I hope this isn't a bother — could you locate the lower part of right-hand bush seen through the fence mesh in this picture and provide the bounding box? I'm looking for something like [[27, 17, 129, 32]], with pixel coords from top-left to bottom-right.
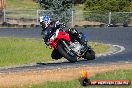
[[83, 12, 132, 24]]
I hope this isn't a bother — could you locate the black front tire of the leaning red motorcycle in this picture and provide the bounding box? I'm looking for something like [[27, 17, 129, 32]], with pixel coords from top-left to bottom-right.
[[57, 44, 77, 63]]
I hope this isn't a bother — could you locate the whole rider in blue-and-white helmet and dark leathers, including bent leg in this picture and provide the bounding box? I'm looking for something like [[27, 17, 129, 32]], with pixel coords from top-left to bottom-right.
[[40, 15, 84, 45]]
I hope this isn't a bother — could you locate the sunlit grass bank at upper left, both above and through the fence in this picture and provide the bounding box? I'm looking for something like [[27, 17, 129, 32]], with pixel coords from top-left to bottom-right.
[[6, 0, 39, 19]]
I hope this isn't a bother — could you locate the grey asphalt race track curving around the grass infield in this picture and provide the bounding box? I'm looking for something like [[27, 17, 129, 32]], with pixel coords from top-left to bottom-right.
[[0, 27, 132, 72]]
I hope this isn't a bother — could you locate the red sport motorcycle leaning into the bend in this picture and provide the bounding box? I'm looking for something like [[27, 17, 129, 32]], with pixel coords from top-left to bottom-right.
[[44, 25, 95, 63]]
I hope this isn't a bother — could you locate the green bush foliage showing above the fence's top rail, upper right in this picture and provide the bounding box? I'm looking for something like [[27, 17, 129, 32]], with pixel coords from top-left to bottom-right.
[[85, 0, 132, 12]]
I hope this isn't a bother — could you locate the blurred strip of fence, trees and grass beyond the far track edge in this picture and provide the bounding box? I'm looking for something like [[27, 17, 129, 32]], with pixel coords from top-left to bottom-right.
[[0, 0, 132, 28]]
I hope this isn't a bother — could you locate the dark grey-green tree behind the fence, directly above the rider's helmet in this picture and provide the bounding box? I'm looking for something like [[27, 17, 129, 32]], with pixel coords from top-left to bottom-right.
[[39, 0, 72, 23]]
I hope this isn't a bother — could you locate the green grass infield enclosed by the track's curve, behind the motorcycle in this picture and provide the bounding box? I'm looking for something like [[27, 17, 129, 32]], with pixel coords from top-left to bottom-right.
[[0, 37, 109, 67]]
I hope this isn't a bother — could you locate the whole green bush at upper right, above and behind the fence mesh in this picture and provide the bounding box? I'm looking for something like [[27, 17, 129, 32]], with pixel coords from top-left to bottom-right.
[[84, 0, 132, 23]]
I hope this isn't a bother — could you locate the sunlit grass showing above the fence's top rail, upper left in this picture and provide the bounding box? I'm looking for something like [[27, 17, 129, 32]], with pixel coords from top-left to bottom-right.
[[6, 0, 39, 10]]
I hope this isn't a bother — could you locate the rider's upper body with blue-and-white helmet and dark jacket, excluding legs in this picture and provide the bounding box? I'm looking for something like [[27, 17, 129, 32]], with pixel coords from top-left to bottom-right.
[[40, 15, 60, 45]]
